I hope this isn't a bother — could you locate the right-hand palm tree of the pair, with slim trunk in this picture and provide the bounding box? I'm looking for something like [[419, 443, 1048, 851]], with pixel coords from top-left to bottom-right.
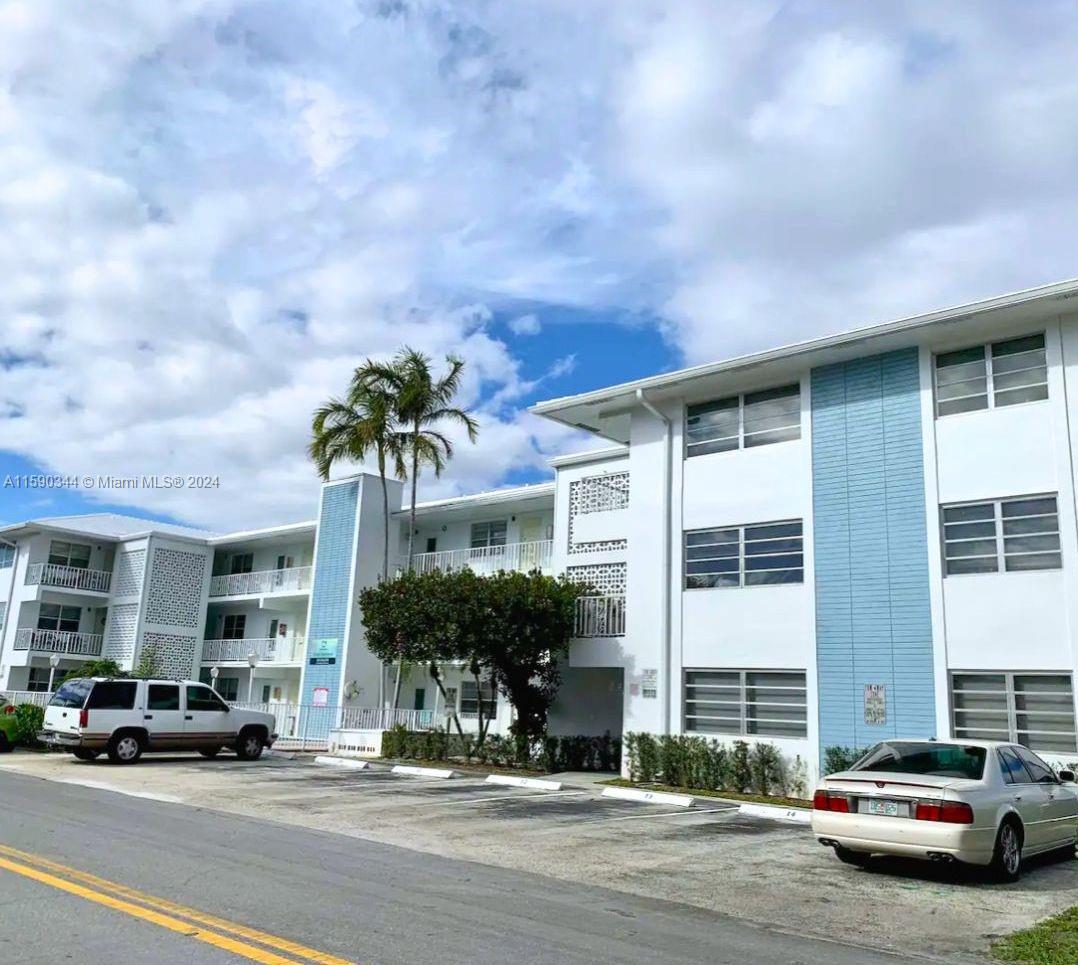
[[392, 346, 479, 573]]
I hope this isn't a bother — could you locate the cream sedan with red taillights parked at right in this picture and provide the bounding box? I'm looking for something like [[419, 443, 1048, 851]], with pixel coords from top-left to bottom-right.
[[812, 741, 1078, 881]]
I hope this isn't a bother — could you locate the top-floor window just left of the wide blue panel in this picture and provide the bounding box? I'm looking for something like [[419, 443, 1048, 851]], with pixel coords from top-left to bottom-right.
[[685, 385, 801, 457]]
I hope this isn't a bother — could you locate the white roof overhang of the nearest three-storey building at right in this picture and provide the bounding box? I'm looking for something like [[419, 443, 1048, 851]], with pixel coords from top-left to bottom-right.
[[530, 279, 1078, 444]]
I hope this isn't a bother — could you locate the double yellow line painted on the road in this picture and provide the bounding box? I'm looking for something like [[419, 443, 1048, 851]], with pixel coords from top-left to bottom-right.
[[0, 844, 353, 965]]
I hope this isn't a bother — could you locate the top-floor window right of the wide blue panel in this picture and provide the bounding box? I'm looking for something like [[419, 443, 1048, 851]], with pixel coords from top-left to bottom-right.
[[936, 333, 1048, 415]]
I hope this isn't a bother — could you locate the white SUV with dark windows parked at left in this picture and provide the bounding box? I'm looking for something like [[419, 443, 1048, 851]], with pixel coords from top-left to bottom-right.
[[38, 677, 277, 764]]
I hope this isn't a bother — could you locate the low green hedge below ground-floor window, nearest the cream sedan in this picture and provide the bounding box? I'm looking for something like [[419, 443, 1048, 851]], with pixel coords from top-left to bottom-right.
[[625, 733, 809, 797]]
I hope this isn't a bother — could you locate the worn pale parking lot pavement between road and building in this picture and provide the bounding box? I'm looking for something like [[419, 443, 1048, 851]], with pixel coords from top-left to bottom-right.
[[0, 755, 1078, 961]]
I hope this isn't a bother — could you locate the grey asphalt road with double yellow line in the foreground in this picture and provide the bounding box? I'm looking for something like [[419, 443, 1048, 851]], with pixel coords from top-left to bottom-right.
[[0, 771, 944, 965]]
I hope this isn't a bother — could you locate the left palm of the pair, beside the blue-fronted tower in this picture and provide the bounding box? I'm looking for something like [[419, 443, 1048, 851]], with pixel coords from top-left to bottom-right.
[[308, 368, 401, 580]]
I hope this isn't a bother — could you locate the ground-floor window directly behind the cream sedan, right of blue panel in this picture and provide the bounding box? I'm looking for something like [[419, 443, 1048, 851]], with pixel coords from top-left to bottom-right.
[[951, 673, 1078, 754]]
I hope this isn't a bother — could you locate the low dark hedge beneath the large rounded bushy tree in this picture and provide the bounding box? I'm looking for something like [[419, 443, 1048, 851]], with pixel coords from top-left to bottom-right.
[[382, 726, 621, 773]]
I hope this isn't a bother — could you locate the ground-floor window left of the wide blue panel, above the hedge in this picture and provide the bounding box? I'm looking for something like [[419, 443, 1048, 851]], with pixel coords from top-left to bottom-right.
[[685, 670, 809, 737]]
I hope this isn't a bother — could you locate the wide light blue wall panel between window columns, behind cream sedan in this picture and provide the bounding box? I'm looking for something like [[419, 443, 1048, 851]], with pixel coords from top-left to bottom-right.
[[812, 349, 936, 749]]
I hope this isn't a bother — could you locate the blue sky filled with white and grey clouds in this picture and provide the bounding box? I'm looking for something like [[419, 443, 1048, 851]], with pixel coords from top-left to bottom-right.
[[0, 0, 1078, 530]]
